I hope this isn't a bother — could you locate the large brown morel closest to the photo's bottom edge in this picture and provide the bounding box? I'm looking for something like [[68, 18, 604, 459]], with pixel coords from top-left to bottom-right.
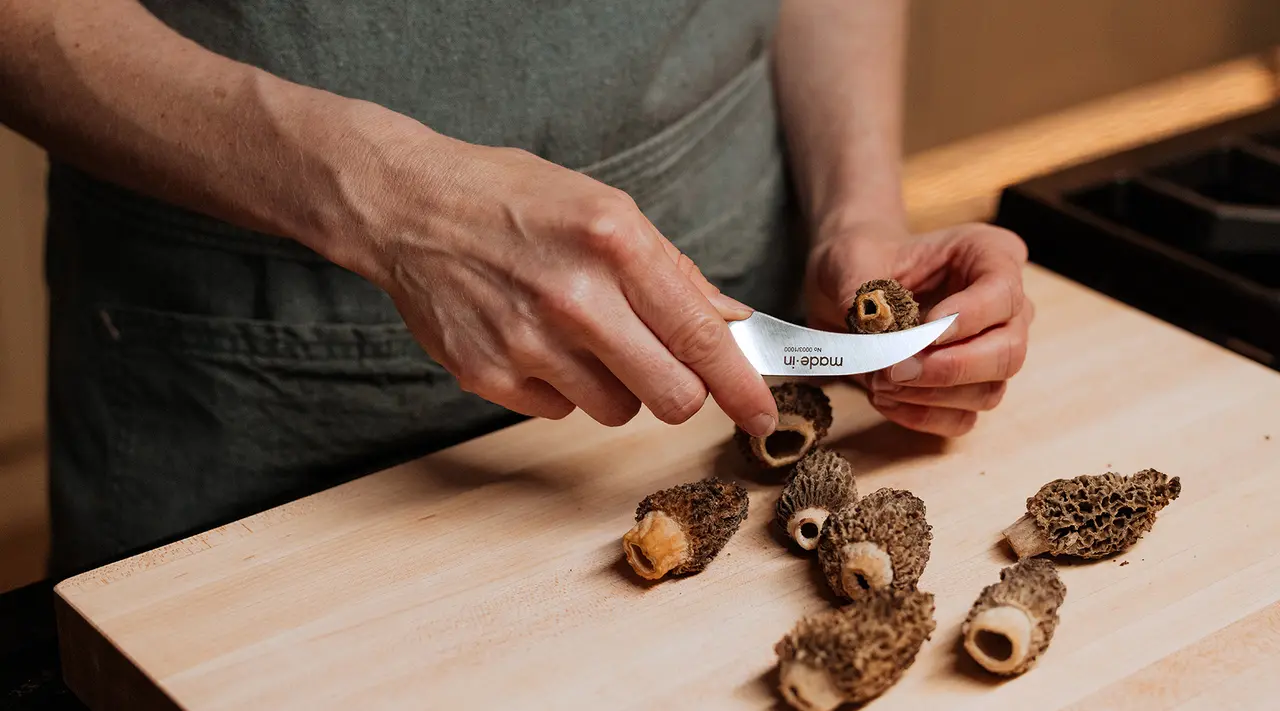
[[773, 591, 936, 711]]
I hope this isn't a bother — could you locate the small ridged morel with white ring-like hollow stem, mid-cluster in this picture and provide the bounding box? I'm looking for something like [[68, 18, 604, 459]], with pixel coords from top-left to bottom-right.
[[774, 447, 858, 551]]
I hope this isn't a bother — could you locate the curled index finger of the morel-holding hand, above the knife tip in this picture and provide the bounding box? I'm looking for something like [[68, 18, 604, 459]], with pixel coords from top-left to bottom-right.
[[925, 237, 1025, 345]]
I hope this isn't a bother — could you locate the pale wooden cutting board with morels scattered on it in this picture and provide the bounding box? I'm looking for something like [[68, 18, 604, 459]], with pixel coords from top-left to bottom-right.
[[58, 268, 1280, 711]]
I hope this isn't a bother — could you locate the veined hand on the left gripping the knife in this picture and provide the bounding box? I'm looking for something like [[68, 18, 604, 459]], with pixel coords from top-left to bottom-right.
[[337, 114, 777, 436]]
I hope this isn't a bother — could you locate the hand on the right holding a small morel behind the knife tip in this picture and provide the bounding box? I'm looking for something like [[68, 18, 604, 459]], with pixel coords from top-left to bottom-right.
[[806, 224, 1034, 437]]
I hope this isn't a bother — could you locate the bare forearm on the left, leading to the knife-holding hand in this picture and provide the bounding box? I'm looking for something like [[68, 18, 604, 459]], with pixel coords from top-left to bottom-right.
[[0, 0, 412, 275]]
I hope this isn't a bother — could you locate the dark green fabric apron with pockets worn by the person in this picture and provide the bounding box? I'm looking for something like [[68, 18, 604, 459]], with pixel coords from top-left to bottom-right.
[[47, 0, 804, 575]]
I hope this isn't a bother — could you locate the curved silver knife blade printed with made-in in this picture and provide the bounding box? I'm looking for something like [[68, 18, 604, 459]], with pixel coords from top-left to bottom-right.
[[728, 311, 959, 377]]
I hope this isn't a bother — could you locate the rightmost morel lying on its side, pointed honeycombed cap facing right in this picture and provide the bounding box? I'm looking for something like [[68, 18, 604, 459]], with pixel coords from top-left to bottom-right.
[[1005, 469, 1183, 559]]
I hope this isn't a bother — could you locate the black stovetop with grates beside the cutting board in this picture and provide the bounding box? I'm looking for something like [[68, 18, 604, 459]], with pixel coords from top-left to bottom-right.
[[995, 105, 1280, 370]]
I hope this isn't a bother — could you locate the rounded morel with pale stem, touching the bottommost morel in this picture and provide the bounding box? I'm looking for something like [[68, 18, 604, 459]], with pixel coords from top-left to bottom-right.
[[818, 488, 933, 600]]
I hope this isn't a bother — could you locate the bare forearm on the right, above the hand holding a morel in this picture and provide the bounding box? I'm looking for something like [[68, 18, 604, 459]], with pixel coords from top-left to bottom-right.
[[774, 0, 908, 240]]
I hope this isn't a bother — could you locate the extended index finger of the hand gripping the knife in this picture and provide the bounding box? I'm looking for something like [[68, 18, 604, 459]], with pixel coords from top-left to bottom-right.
[[622, 242, 778, 437]]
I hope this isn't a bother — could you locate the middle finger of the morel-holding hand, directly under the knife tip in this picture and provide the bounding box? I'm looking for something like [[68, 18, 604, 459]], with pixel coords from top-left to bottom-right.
[[887, 306, 1030, 388]]
